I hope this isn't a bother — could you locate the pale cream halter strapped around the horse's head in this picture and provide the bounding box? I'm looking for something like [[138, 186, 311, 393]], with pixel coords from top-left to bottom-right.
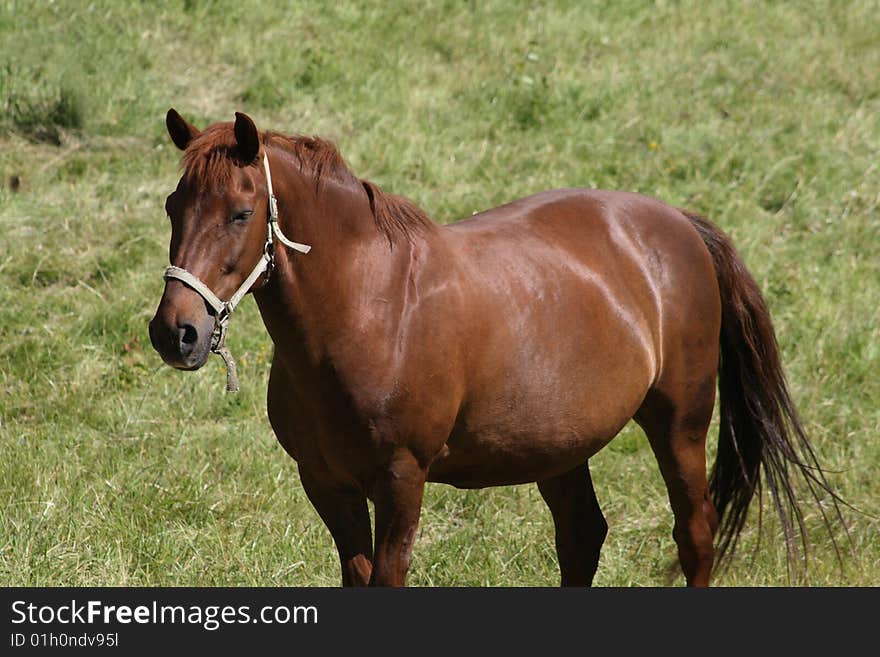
[[164, 152, 312, 392]]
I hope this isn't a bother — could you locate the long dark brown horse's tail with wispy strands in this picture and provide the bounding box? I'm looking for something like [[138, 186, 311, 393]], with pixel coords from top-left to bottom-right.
[[685, 211, 842, 561]]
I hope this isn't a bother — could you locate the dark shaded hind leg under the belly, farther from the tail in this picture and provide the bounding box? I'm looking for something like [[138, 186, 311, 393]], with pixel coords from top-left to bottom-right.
[[538, 463, 608, 586]]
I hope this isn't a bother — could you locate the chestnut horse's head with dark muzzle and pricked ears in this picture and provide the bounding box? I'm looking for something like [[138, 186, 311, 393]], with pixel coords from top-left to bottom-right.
[[150, 109, 268, 370]]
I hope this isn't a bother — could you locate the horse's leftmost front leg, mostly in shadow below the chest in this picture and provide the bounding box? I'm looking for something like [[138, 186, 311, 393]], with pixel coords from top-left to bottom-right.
[[299, 465, 373, 586]]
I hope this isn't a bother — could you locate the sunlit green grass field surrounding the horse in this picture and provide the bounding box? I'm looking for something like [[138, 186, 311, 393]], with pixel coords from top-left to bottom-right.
[[0, 0, 880, 586]]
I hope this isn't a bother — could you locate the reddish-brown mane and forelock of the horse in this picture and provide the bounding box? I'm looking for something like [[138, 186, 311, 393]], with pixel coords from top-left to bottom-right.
[[183, 123, 431, 244]]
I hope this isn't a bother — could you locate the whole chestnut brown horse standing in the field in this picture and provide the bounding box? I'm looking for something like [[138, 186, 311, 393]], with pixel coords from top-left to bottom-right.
[[150, 110, 836, 586]]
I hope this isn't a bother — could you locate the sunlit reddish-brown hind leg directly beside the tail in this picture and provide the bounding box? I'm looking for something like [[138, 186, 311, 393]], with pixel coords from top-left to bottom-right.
[[635, 372, 718, 586]]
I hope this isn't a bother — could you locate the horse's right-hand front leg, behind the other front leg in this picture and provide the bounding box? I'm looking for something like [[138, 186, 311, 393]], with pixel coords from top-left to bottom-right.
[[370, 449, 427, 586]]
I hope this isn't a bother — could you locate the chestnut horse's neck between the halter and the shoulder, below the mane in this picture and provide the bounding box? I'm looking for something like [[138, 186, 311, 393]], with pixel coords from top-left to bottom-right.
[[255, 157, 424, 364]]
